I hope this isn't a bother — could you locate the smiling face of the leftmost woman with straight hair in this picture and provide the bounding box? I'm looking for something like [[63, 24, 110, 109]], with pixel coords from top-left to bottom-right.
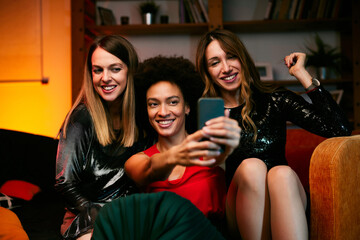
[[91, 47, 128, 103]]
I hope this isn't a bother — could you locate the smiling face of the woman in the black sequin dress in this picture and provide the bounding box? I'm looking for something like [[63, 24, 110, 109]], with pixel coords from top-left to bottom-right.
[[205, 40, 241, 92]]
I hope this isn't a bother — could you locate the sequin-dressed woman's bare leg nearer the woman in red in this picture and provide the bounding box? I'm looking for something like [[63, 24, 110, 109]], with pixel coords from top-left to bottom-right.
[[226, 158, 270, 240]]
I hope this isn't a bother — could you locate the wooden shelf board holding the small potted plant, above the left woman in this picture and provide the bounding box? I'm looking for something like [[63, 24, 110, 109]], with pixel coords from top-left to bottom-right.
[[86, 23, 208, 35]]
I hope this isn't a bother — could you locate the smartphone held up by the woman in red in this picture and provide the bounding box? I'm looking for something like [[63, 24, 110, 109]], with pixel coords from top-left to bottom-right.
[[197, 98, 224, 129]]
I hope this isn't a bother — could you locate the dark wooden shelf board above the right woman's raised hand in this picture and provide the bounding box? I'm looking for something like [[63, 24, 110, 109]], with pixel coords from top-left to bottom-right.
[[223, 19, 351, 33]]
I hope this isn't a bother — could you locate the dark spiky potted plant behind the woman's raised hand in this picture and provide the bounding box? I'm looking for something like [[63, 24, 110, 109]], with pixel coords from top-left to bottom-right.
[[305, 34, 342, 79]]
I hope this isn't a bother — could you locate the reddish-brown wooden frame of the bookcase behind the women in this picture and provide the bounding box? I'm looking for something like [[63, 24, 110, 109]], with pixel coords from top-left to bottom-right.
[[71, 0, 360, 129]]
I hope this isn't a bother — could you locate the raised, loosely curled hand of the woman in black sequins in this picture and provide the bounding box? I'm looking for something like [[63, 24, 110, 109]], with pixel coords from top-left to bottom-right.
[[284, 52, 312, 89]]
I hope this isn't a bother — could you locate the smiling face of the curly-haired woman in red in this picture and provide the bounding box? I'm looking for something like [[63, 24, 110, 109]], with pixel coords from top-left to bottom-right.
[[146, 81, 190, 140]]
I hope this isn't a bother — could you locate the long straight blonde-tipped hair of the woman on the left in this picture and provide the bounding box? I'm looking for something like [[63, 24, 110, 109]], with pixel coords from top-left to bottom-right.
[[63, 35, 138, 147]]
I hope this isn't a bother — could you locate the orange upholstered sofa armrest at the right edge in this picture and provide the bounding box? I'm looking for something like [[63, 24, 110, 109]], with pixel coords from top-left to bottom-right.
[[309, 135, 360, 240]]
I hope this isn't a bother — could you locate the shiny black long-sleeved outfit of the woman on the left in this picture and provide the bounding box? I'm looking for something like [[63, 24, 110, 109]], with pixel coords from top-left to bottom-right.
[[55, 105, 146, 238]]
